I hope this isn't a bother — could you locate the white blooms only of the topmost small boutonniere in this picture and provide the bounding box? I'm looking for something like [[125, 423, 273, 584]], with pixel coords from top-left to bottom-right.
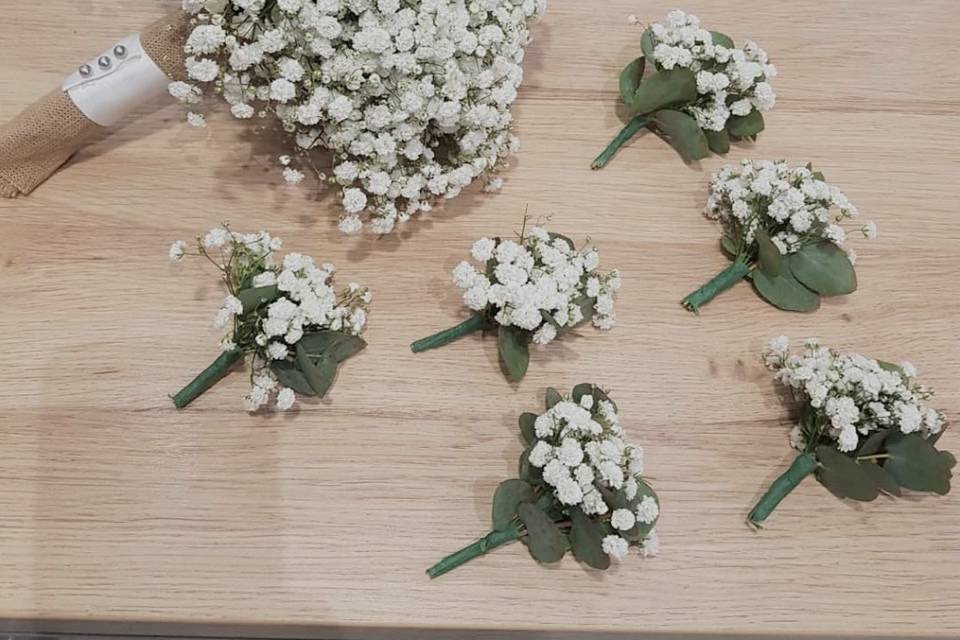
[[650, 10, 777, 131]]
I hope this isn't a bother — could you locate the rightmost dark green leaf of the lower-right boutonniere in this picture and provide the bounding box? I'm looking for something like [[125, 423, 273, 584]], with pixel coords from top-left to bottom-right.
[[883, 431, 953, 495]]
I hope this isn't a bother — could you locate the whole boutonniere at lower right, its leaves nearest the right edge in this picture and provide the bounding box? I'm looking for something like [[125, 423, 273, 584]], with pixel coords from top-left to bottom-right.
[[749, 336, 957, 526]]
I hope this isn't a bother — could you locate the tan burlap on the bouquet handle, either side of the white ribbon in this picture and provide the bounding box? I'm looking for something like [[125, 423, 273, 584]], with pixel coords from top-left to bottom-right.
[[0, 12, 190, 198]]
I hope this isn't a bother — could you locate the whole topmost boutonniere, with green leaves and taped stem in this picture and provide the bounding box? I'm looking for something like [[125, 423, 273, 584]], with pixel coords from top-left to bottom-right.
[[593, 11, 777, 169]]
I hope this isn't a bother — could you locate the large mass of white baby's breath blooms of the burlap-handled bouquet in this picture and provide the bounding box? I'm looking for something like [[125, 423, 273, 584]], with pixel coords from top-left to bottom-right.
[[170, 0, 546, 234]]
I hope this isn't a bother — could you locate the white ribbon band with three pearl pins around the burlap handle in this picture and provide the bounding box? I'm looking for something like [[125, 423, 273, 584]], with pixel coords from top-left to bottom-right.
[[62, 33, 170, 127]]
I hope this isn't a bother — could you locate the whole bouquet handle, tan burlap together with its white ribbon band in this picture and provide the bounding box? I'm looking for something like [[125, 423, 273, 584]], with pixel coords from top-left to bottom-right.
[[0, 12, 190, 198]]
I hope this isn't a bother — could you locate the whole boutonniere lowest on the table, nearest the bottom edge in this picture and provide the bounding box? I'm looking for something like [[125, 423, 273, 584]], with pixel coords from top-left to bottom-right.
[[427, 384, 660, 578]]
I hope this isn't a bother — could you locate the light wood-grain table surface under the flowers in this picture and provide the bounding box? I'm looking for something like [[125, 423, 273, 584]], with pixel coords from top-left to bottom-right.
[[0, 0, 960, 638]]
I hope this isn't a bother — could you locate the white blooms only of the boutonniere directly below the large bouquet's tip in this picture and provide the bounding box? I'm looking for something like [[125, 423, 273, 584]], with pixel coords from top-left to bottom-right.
[[453, 227, 620, 344]]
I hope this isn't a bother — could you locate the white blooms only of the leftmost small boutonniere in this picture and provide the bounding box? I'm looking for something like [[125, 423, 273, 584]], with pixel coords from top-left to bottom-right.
[[169, 227, 371, 412]]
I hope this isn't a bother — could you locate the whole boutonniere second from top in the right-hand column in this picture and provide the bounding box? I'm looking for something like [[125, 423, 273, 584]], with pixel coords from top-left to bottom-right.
[[683, 160, 877, 313]]
